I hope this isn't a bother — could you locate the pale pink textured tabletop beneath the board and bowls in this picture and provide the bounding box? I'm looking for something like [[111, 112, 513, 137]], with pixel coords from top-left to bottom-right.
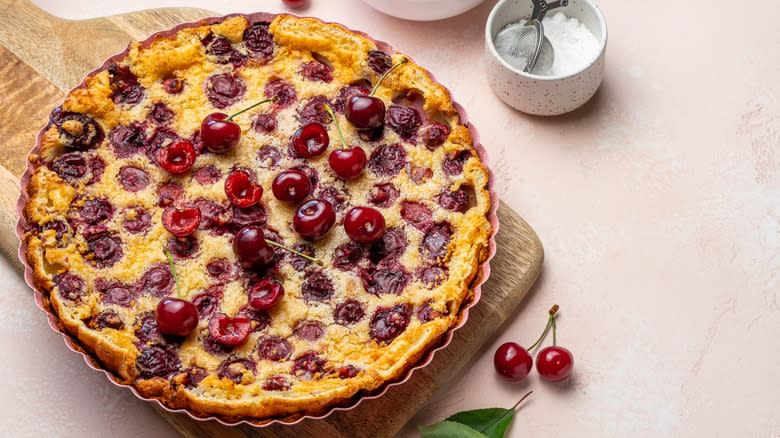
[[0, 0, 780, 438]]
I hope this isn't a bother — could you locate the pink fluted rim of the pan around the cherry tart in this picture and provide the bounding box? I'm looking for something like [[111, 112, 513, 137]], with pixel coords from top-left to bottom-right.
[[16, 13, 498, 427]]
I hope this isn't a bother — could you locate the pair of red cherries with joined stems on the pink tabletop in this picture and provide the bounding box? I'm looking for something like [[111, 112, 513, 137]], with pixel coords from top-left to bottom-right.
[[493, 304, 574, 382]]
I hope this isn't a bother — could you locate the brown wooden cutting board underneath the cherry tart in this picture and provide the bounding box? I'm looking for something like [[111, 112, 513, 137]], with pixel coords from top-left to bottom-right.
[[0, 0, 543, 438]]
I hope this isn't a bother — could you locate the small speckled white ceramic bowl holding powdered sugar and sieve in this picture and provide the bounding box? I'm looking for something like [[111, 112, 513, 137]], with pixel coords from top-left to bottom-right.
[[485, 0, 607, 116]]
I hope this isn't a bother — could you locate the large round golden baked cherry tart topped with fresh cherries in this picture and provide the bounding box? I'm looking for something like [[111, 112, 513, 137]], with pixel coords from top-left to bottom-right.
[[21, 14, 493, 424]]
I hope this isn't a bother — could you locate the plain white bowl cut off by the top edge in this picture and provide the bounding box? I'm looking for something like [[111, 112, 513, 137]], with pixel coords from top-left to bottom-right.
[[363, 0, 485, 21]]
